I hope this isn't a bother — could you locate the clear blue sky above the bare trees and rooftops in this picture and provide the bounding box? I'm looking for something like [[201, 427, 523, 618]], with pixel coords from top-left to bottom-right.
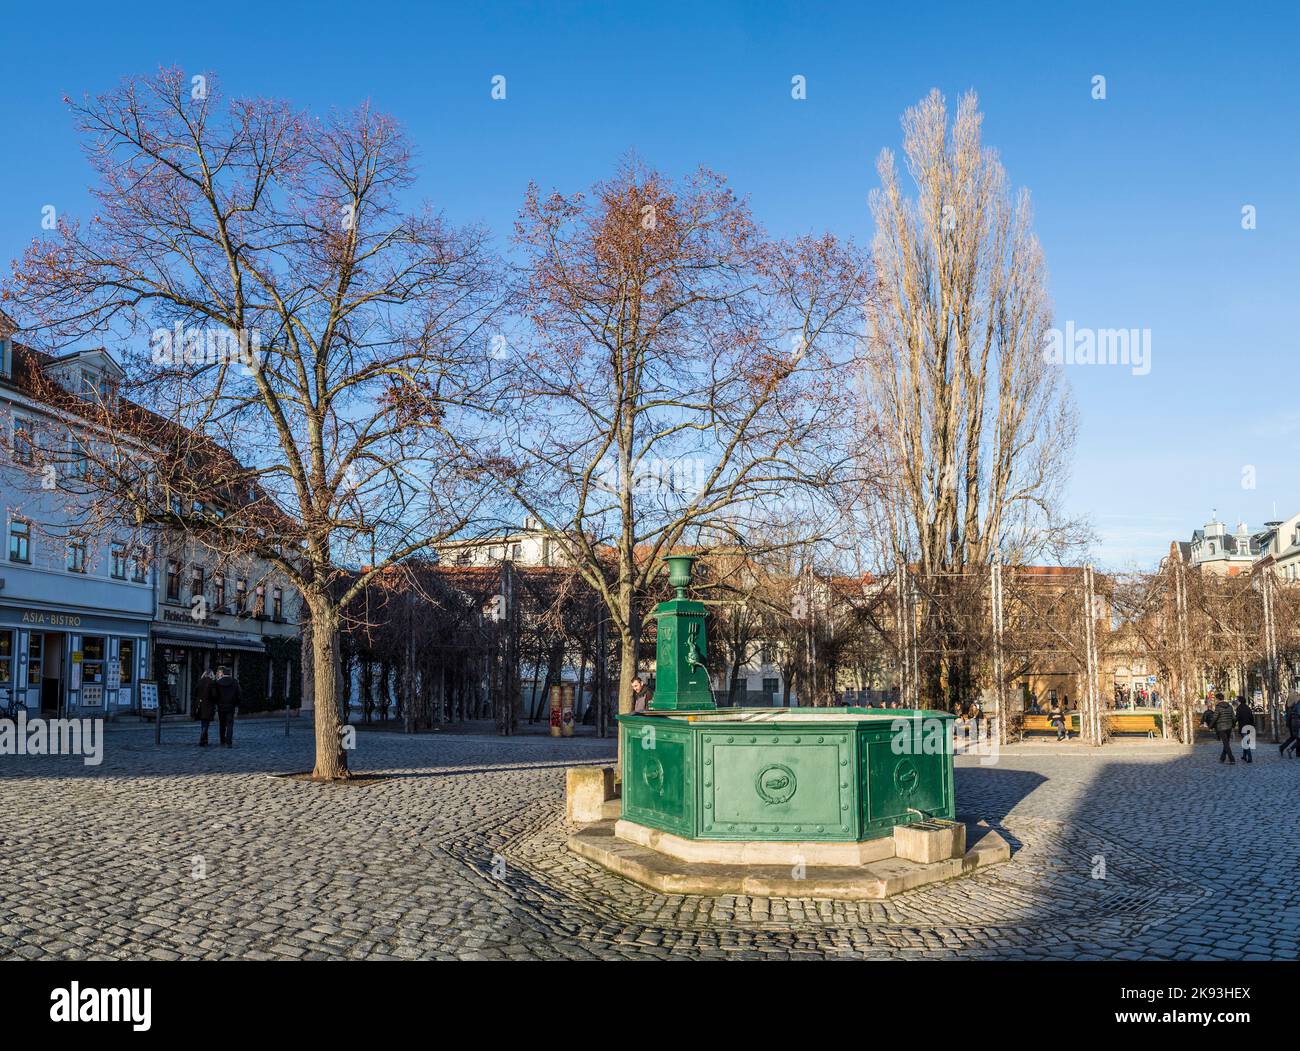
[[0, 0, 1300, 566]]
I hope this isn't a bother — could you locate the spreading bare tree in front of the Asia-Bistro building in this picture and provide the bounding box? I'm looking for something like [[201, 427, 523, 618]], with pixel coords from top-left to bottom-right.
[[3, 70, 494, 779]]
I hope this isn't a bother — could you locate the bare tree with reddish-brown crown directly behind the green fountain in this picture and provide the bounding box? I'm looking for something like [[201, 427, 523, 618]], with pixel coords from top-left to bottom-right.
[[491, 161, 868, 738]]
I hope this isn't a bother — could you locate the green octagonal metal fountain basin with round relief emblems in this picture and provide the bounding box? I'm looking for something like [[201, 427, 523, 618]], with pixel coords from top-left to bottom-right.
[[619, 708, 954, 842]]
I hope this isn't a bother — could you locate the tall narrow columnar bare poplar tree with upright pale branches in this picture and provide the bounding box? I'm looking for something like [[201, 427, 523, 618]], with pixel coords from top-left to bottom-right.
[[863, 90, 1087, 712]]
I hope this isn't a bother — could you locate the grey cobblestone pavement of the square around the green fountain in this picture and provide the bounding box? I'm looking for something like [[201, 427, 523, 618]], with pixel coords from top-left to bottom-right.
[[0, 721, 1300, 960]]
